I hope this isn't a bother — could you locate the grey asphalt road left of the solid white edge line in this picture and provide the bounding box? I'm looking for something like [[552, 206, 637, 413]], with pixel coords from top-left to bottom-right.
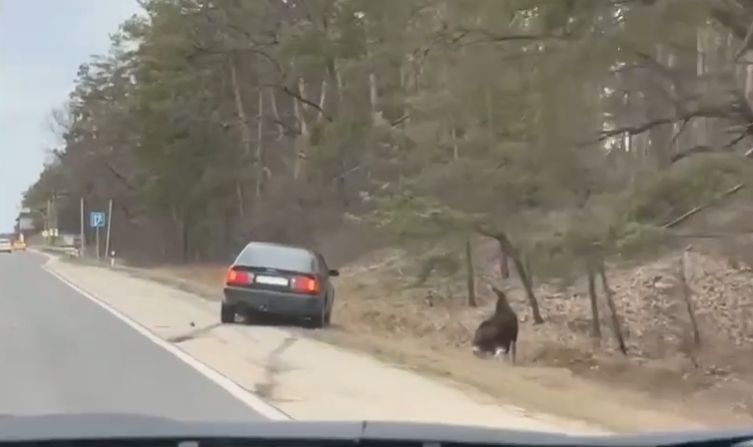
[[0, 253, 263, 421]]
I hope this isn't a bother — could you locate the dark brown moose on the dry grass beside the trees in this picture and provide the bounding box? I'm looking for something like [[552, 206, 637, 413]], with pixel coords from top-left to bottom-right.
[[473, 285, 518, 363]]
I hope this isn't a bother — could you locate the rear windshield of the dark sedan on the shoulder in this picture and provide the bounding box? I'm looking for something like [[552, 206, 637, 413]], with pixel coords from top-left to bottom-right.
[[235, 244, 316, 273]]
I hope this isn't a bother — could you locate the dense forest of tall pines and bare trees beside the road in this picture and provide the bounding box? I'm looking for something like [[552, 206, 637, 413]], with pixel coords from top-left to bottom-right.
[[23, 0, 753, 292]]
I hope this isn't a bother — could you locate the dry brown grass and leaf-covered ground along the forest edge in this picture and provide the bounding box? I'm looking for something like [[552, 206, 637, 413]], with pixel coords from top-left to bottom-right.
[[137, 246, 753, 431]]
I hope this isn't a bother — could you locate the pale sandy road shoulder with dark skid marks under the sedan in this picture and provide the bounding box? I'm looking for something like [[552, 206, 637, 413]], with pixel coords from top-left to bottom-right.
[[39, 257, 605, 433]]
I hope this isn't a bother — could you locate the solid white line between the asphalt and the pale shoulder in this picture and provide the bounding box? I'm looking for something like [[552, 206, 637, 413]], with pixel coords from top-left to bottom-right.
[[43, 258, 292, 420]]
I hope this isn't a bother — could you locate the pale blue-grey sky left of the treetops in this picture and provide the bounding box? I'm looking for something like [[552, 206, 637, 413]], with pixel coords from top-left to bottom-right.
[[0, 0, 139, 233]]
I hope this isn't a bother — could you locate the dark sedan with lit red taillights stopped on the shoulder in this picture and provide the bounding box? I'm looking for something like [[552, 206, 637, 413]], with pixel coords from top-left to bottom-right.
[[220, 242, 339, 327]]
